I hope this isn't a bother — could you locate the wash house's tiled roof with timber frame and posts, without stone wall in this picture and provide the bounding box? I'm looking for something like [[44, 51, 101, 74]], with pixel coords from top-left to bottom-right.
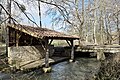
[[8, 24, 79, 68]]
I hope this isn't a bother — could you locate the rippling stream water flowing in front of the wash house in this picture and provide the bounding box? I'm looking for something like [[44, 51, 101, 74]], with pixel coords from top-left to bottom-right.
[[0, 58, 100, 80]]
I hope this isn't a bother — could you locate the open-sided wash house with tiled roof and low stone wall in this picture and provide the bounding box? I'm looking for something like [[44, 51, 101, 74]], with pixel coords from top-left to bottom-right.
[[7, 24, 79, 71]]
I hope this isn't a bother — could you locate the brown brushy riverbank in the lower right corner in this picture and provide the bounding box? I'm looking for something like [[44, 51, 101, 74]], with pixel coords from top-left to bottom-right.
[[96, 53, 120, 80]]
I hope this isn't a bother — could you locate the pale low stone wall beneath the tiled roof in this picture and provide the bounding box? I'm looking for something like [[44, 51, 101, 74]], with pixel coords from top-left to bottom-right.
[[8, 46, 54, 68]]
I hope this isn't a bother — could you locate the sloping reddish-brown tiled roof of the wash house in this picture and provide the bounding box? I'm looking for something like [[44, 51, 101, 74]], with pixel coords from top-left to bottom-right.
[[9, 25, 79, 39]]
